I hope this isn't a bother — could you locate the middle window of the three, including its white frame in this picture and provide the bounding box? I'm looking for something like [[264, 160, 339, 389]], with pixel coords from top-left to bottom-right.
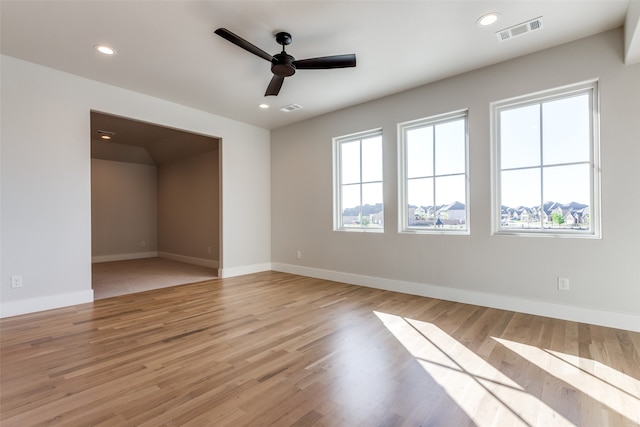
[[398, 110, 469, 234]]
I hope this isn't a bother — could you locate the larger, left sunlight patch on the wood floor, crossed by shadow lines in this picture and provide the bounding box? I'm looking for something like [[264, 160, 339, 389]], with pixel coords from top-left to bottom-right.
[[374, 311, 574, 426]]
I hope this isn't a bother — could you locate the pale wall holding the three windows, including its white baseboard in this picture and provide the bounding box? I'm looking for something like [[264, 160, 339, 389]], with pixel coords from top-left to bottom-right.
[[271, 30, 640, 330]]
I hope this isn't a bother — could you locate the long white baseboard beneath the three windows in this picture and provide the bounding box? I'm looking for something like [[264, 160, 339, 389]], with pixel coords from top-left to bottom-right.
[[271, 263, 640, 332]]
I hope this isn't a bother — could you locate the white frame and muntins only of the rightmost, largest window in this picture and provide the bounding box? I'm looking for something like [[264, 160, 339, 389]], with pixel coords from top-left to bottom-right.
[[490, 79, 602, 239]]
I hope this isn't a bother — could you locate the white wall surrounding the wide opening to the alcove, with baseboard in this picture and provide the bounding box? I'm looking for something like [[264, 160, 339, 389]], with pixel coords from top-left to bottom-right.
[[0, 55, 271, 316]]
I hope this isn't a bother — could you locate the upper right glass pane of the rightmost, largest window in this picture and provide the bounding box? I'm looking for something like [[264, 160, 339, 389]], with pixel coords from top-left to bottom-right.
[[542, 94, 590, 165]]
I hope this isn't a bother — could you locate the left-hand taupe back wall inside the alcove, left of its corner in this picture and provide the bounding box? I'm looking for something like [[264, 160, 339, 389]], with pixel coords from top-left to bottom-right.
[[91, 159, 158, 259]]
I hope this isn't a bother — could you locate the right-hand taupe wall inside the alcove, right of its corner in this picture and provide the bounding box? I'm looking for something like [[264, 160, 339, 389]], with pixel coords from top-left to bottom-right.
[[158, 151, 220, 261]]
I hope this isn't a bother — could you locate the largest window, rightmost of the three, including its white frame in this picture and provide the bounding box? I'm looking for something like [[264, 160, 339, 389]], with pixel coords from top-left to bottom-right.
[[492, 82, 599, 237]]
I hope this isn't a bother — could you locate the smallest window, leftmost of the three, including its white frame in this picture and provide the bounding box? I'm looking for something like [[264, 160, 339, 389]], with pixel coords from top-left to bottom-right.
[[333, 130, 384, 232]]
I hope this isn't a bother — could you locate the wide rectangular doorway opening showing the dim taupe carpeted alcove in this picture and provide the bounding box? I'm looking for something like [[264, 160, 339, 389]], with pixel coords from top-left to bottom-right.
[[91, 111, 221, 299]]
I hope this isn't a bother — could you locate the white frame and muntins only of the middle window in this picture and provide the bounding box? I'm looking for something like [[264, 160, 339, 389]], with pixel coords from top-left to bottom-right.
[[397, 108, 471, 235]]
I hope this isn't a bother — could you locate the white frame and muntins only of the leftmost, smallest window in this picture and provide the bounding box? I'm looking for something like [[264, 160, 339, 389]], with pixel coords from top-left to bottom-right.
[[332, 128, 386, 233]]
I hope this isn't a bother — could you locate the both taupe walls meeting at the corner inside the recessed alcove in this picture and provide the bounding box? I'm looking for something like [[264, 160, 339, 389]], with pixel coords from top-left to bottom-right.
[[91, 149, 220, 268]]
